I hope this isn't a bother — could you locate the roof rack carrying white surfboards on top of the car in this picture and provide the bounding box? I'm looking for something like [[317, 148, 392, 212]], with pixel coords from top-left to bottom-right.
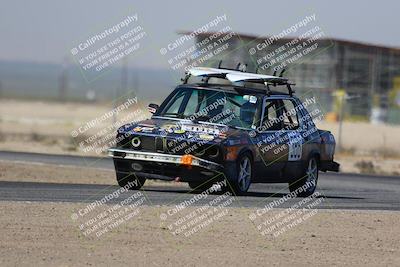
[[182, 60, 295, 96]]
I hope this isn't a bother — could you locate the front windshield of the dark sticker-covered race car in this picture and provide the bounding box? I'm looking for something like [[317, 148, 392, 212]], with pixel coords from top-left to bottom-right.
[[155, 88, 261, 129]]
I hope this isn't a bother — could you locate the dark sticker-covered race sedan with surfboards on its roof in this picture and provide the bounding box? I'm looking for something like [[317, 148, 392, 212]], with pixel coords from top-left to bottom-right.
[[108, 68, 339, 196]]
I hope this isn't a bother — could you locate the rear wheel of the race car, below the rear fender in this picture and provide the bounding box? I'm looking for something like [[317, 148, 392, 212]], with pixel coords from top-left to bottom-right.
[[289, 156, 319, 197]]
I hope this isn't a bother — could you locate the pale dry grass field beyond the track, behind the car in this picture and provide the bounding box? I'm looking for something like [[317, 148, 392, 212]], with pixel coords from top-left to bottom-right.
[[0, 99, 400, 175]]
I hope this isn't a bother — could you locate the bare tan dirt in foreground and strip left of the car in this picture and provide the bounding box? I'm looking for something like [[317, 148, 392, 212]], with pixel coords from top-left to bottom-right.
[[0, 161, 400, 266]]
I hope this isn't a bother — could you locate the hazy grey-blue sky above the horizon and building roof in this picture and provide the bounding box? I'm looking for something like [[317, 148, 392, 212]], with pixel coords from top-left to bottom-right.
[[0, 0, 400, 68]]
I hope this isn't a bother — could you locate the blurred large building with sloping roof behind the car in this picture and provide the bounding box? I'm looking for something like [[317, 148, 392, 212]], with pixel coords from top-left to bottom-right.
[[183, 32, 400, 122]]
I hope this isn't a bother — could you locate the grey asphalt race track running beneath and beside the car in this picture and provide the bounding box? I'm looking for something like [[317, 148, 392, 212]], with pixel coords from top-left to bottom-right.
[[0, 151, 400, 210]]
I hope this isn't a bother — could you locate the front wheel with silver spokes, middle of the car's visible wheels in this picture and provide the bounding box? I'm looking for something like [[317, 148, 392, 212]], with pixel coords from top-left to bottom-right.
[[226, 153, 253, 195]]
